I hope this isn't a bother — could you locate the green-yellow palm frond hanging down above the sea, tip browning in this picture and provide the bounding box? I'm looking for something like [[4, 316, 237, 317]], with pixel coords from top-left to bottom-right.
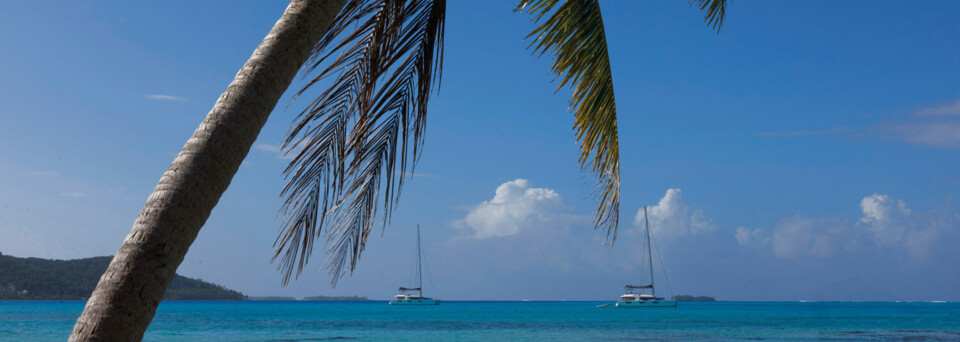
[[516, 0, 620, 242]]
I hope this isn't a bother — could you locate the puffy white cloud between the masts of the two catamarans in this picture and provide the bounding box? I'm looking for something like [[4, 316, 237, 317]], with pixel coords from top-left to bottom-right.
[[454, 179, 562, 239]]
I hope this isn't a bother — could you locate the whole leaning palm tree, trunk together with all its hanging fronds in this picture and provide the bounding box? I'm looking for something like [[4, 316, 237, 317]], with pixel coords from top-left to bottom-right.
[[70, 0, 725, 341]]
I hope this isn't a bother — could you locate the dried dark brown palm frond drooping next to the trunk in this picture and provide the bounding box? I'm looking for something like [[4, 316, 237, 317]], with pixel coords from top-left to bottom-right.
[[273, 0, 446, 286]]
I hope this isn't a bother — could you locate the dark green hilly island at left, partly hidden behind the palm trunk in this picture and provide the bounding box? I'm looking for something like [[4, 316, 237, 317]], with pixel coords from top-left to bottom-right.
[[0, 254, 246, 300]]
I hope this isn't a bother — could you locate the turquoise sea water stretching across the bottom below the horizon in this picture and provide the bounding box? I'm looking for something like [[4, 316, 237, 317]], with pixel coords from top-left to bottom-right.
[[0, 301, 960, 341]]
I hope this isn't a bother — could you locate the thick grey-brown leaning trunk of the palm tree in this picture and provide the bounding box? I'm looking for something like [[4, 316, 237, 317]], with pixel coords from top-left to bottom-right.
[[70, 0, 344, 341]]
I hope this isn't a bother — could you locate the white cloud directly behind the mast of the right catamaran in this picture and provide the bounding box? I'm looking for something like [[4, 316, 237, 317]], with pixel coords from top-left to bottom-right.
[[633, 188, 716, 241]]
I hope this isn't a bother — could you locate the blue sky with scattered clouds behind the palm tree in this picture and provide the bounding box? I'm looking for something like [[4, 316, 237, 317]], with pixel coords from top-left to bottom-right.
[[0, 1, 960, 300]]
